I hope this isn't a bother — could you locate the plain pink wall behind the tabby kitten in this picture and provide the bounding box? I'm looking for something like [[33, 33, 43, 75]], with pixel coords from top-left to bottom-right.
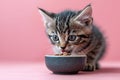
[[0, 0, 120, 62]]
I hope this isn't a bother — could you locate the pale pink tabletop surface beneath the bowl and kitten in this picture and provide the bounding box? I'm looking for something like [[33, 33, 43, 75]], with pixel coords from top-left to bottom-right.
[[0, 63, 120, 80]]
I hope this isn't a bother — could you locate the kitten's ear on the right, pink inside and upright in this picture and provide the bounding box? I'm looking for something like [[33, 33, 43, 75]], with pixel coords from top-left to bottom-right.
[[73, 5, 93, 26]]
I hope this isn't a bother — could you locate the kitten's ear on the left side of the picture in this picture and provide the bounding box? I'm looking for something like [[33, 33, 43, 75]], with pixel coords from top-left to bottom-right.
[[39, 8, 54, 24]]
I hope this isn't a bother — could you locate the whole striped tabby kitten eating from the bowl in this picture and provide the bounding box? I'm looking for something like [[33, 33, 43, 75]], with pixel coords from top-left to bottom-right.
[[39, 5, 105, 71]]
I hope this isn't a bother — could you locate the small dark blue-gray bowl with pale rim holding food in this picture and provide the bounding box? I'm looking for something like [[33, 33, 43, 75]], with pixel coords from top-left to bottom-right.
[[45, 55, 86, 74]]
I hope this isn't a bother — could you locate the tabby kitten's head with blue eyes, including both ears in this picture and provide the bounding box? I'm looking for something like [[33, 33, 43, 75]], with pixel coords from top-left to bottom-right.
[[39, 5, 93, 53]]
